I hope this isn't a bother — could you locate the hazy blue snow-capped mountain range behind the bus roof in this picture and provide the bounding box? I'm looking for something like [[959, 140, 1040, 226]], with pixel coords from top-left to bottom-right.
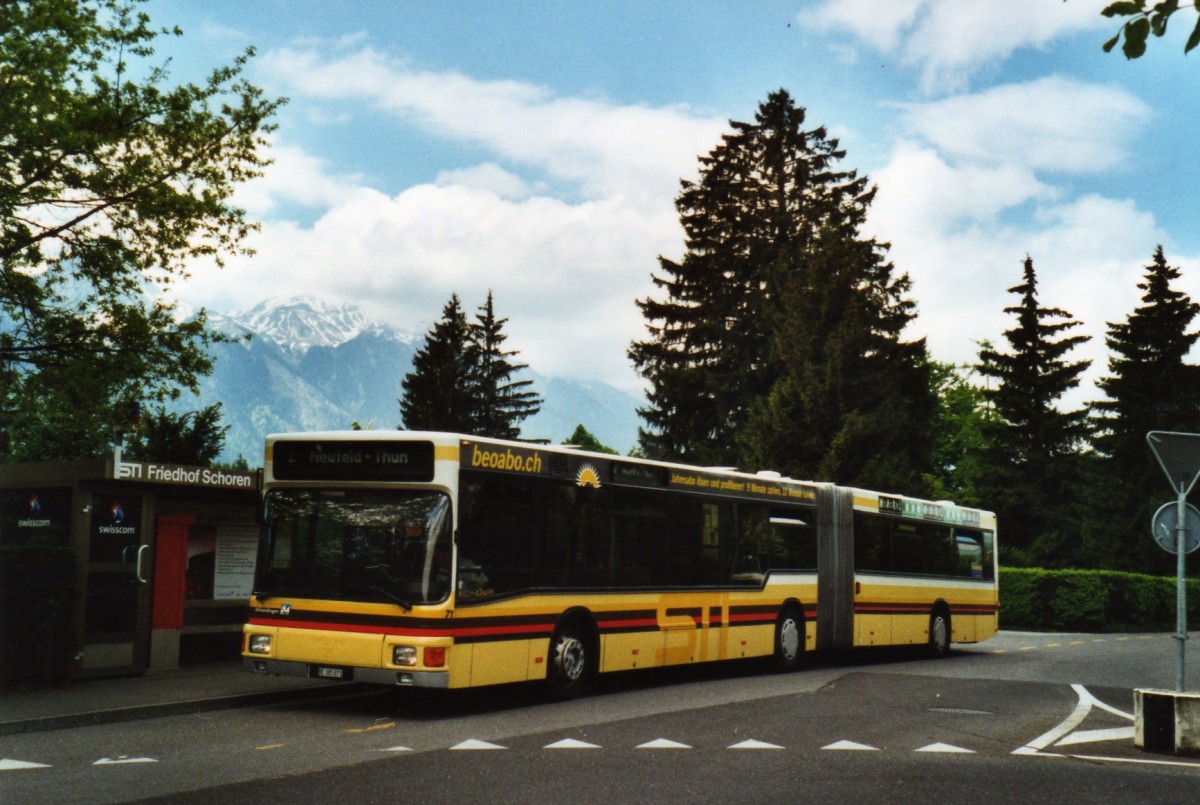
[[175, 298, 642, 465]]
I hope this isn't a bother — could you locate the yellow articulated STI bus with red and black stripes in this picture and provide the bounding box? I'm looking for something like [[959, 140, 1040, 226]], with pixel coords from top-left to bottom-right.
[[242, 431, 998, 696]]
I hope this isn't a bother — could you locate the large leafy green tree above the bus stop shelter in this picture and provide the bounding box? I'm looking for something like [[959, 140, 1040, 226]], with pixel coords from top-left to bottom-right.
[[0, 0, 281, 458]]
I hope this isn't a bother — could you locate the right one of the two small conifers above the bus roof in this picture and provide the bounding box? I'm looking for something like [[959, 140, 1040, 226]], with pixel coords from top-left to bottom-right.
[[470, 290, 541, 439]]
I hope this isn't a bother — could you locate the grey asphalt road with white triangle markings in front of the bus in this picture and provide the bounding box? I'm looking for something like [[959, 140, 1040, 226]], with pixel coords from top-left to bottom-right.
[[7, 633, 1200, 804]]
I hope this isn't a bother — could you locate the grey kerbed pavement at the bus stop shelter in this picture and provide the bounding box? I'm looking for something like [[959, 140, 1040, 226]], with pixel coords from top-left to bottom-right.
[[0, 657, 349, 735]]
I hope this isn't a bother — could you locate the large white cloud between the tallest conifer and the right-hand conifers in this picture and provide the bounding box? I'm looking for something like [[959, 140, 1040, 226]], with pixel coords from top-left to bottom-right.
[[870, 77, 1165, 407]]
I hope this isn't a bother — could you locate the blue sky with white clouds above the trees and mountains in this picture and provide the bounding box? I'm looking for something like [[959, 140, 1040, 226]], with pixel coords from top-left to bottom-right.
[[146, 0, 1200, 401]]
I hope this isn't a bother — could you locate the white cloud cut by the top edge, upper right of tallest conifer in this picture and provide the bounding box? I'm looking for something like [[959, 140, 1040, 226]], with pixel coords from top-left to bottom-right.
[[798, 0, 1111, 92]]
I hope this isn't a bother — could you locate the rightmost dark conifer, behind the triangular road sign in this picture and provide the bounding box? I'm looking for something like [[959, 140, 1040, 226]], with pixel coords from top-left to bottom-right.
[[1084, 246, 1200, 572]]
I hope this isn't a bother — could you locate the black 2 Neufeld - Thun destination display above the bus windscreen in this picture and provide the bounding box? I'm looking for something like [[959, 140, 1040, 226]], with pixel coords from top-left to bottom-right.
[[271, 440, 433, 482]]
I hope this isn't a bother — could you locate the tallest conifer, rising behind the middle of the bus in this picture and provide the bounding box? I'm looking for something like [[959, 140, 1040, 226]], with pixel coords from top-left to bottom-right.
[[629, 90, 874, 464]]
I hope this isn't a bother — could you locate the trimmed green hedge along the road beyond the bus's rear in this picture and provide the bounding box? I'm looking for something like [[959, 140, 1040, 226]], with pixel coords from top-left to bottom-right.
[[1000, 567, 1200, 632]]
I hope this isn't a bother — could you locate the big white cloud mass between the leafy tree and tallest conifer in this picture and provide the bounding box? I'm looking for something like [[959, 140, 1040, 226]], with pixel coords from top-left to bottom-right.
[[180, 44, 725, 388]]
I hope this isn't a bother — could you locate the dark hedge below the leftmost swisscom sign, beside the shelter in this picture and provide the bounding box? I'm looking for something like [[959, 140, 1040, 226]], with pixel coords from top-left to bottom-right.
[[0, 546, 78, 690]]
